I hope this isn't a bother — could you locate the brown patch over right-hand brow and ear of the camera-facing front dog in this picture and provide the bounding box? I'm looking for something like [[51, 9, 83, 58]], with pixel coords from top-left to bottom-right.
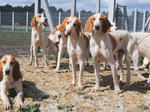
[[100, 14, 111, 33]]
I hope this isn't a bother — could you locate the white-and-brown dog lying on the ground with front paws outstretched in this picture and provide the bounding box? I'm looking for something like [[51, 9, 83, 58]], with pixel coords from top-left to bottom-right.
[[0, 54, 23, 110]]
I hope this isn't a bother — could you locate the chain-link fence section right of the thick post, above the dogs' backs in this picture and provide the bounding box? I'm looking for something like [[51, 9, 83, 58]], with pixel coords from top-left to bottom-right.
[[116, 5, 150, 32]]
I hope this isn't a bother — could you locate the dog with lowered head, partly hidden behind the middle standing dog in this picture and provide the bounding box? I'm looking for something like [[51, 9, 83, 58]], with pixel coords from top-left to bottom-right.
[[47, 25, 70, 71]]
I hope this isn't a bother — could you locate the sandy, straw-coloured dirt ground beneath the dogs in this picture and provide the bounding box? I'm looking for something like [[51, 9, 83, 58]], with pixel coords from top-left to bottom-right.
[[0, 55, 150, 112]]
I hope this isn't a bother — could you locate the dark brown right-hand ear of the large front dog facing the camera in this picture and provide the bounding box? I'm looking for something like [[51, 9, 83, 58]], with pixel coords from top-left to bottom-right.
[[102, 16, 111, 33]]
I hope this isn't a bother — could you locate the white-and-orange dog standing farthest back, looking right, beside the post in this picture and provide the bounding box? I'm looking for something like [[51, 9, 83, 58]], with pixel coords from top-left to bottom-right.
[[29, 14, 48, 68]]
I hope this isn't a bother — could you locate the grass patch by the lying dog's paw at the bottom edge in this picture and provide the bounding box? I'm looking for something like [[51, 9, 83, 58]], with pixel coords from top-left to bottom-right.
[[17, 103, 40, 112]]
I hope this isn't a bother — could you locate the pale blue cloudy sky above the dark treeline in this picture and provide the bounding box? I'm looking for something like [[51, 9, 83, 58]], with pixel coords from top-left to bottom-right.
[[0, 0, 150, 12]]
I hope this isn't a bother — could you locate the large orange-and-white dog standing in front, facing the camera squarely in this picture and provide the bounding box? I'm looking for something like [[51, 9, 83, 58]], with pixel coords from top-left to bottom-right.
[[85, 13, 130, 93]]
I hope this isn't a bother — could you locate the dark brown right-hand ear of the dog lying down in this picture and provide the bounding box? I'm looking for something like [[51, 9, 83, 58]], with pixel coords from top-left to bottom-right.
[[13, 60, 21, 81]]
